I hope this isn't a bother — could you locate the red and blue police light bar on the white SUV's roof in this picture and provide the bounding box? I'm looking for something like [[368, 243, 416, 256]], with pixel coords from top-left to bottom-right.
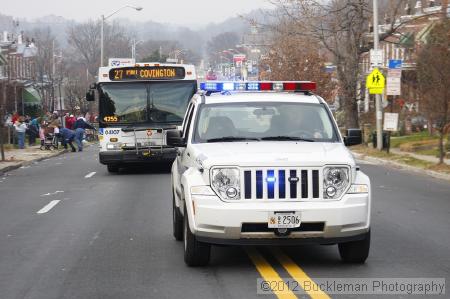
[[200, 81, 316, 92]]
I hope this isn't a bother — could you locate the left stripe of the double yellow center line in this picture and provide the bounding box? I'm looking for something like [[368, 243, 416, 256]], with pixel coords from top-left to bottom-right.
[[245, 247, 298, 299]]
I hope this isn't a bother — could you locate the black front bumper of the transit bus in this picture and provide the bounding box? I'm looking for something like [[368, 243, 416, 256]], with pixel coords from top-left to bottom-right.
[[99, 148, 177, 165]]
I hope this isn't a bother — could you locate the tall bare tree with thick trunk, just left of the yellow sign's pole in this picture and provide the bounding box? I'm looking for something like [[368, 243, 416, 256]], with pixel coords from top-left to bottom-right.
[[273, 0, 410, 128]]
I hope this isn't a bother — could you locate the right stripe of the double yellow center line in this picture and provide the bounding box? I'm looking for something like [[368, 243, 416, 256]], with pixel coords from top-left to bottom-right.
[[271, 247, 330, 299]]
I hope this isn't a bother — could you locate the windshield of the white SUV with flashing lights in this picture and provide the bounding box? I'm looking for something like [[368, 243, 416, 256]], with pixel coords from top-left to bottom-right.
[[194, 102, 338, 143]]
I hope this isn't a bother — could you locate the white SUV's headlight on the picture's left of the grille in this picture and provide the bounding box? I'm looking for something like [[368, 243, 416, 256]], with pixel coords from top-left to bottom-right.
[[211, 168, 241, 200]]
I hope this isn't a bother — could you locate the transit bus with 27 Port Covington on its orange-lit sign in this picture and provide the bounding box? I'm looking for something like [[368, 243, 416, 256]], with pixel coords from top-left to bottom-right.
[[86, 63, 197, 172]]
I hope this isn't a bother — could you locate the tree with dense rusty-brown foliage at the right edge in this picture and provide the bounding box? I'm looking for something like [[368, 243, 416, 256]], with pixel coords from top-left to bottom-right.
[[417, 19, 450, 163]]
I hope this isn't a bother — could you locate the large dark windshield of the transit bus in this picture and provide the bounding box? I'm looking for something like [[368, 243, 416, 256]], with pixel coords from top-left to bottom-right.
[[99, 81, 197, 124]]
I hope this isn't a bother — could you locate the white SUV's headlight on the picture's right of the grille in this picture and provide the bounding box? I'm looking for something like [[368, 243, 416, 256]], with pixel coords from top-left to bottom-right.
[[323, 167, 350, 199]]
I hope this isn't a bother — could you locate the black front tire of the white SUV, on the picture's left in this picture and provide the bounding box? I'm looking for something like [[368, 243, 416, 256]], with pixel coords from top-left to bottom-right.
[[183, 207, 211, 267]]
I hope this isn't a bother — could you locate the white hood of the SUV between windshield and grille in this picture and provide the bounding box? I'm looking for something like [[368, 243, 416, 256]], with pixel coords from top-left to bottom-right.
[[191, 141, 355, 168]]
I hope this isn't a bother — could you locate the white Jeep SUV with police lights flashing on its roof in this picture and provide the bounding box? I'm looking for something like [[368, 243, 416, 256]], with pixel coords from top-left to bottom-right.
[[167, 82, 371, 266]]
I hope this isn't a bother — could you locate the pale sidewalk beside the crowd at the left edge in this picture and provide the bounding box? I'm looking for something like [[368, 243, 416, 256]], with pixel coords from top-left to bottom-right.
[[0, 145, 66, 174]]
